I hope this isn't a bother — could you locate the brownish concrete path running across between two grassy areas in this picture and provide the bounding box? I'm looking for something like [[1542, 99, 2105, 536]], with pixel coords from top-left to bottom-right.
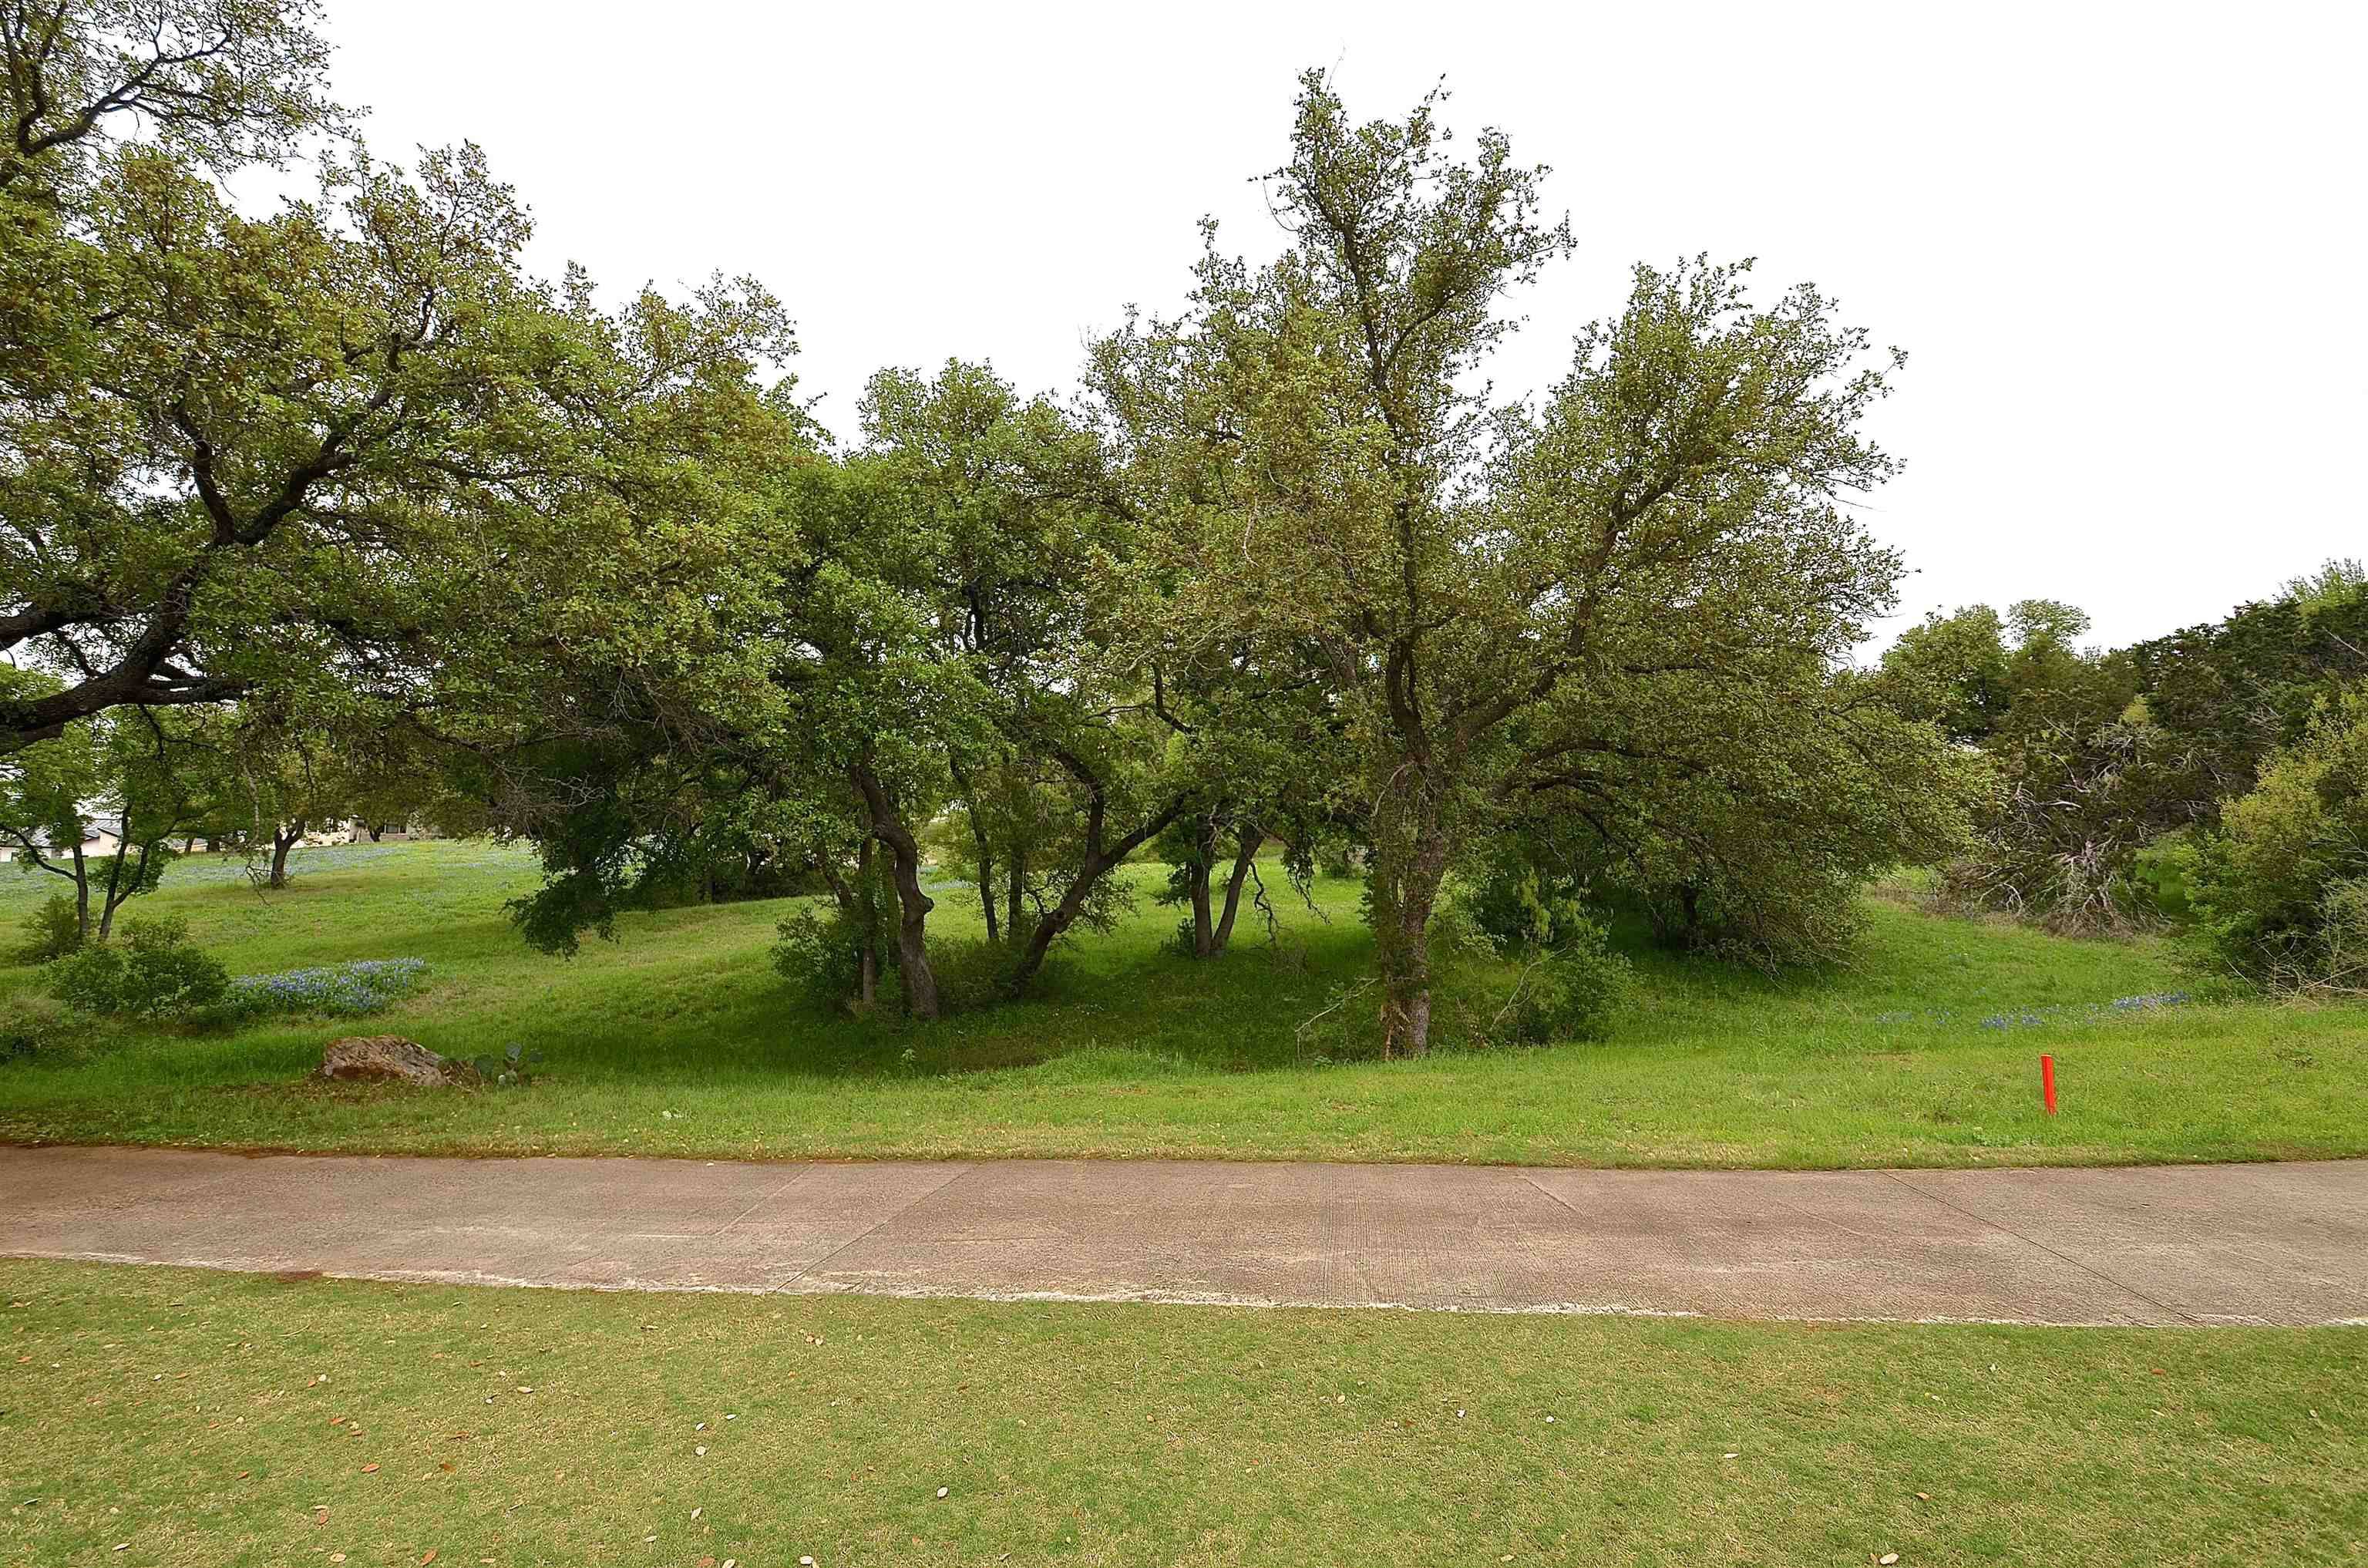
[[0, 1149, 2368, 1324]]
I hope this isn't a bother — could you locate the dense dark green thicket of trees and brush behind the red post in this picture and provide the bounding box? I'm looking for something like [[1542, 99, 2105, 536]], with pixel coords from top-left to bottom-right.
[[1878, 561, 2368, 990]]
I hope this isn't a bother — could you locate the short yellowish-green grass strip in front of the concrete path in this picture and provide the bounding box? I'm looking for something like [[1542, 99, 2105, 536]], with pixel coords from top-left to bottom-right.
[[0, 1263, 2368, 1568]]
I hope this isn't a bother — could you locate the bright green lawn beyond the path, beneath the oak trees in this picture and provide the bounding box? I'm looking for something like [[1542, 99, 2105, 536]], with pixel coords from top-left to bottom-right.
[[0, 843, 2368, 1168]]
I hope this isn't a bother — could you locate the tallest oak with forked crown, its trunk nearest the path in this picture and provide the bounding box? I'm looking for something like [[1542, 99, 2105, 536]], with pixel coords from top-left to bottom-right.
[[1094, 73, 1970, 1054]]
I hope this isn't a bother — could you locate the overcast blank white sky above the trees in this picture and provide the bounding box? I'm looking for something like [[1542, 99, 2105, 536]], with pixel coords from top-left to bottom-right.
[[305, 0, 2368, 644]]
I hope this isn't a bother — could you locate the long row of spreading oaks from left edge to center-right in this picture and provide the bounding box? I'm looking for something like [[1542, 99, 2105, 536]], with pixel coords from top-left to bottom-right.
[[0, 0, 1986, 1054]]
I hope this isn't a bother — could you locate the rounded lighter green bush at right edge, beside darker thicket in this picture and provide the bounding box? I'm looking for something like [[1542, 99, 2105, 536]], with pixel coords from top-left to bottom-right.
[[2178, 685, 2368, 994]]
